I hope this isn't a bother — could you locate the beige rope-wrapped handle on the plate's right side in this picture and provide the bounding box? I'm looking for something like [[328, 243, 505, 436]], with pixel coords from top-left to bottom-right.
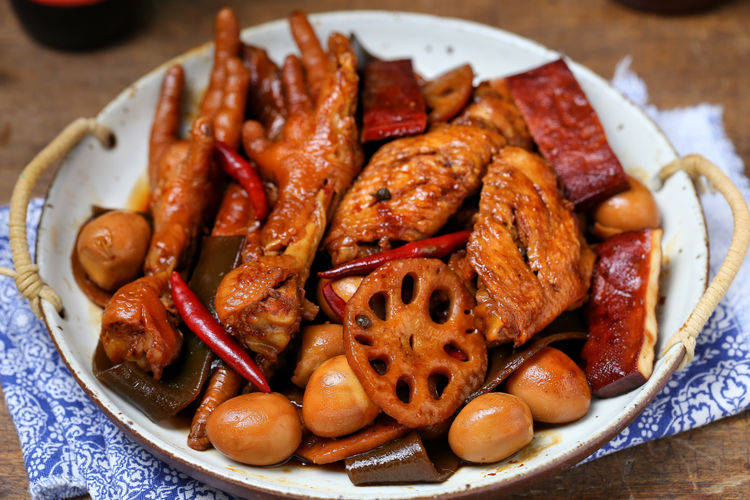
[[659, 155, 750, 370]]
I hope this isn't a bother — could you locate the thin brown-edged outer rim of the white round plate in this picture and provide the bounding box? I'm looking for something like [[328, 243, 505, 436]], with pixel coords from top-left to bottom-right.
[[34, 9, 710, 500]]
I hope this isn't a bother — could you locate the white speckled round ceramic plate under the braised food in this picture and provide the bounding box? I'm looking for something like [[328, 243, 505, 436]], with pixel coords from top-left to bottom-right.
[[37, 11, 708, 498]]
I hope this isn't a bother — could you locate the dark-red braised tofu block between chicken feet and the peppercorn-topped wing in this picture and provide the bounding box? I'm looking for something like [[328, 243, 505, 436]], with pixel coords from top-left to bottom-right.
[[362, 59, 427, 142]]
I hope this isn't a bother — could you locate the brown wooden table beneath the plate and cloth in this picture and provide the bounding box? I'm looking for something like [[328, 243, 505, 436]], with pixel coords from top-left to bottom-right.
[[0, 0, 750, 498]]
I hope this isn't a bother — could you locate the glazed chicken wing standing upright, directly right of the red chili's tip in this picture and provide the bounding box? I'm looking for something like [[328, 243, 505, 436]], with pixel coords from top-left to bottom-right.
[[467, 147, 594, 345]]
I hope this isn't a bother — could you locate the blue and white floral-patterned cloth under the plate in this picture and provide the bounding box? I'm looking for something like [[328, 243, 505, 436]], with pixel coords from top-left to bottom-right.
[[0, 60, 750, 499]]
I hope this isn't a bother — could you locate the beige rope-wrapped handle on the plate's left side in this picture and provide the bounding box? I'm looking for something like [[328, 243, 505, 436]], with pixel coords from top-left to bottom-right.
[[0, 118, 114, 319]]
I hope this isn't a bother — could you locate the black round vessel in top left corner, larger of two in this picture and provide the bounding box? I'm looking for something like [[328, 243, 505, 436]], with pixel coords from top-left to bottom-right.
[[11, 0, 142, 50]]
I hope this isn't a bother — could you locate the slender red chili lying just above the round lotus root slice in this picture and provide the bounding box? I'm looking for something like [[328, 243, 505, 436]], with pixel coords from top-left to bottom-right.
[[318, 231, 471, 282]]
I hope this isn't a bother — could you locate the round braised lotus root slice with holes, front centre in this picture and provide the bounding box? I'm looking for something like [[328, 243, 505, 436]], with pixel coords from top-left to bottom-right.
[[344, 259, 487, 427]]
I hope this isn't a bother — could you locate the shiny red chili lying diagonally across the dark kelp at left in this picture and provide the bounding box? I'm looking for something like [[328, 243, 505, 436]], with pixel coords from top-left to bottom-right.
[[169, 272, 271, 392]]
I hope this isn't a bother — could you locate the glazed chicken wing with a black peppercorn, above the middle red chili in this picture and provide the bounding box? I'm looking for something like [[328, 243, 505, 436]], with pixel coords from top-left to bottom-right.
[[324, 125, 504, 265]]
